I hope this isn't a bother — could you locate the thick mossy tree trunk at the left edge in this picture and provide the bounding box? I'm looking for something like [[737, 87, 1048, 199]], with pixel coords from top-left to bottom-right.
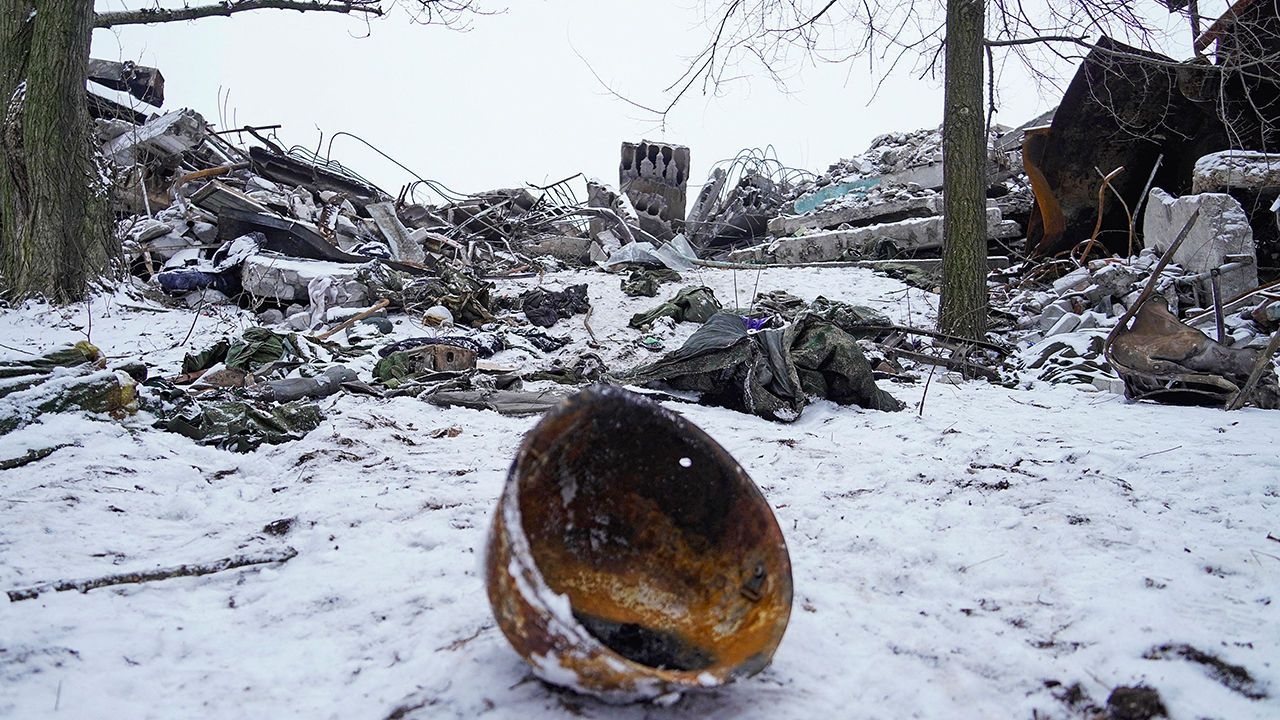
[[0, 0, 119, 302]]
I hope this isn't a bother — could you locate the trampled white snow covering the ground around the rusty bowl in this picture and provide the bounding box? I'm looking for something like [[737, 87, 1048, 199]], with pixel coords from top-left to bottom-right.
[[0, 269, 1280, 720]]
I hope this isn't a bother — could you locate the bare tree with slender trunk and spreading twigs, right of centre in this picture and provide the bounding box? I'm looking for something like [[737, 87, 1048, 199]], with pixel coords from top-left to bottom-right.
[[680, 0, 1198, 338]]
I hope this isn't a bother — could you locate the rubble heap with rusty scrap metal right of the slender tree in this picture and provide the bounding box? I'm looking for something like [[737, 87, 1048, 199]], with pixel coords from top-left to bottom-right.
[[993, 170, 1280, 407]]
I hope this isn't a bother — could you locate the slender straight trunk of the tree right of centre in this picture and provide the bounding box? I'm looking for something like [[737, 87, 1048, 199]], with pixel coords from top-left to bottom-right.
[[938, 0, 987, 340]]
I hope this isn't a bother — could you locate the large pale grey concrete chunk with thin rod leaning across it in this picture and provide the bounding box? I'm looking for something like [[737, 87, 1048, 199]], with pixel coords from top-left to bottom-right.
[[1143, 187, 1258, 297]]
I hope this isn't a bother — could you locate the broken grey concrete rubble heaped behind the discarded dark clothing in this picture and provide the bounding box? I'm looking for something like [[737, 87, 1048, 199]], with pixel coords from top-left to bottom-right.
[[70, 37, 1280, 421]]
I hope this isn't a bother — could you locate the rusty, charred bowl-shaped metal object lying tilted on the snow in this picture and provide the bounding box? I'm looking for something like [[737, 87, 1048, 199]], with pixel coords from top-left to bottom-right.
[[485, 386, 791, 702]]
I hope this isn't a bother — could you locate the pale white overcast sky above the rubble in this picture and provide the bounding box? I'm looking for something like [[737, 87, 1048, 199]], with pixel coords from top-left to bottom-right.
[[93, 0, 1187, 202]]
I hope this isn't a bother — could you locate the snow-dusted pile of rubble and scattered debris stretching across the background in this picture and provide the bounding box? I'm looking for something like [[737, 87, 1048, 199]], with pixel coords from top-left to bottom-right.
[[32, 16, 1280, 448]]
